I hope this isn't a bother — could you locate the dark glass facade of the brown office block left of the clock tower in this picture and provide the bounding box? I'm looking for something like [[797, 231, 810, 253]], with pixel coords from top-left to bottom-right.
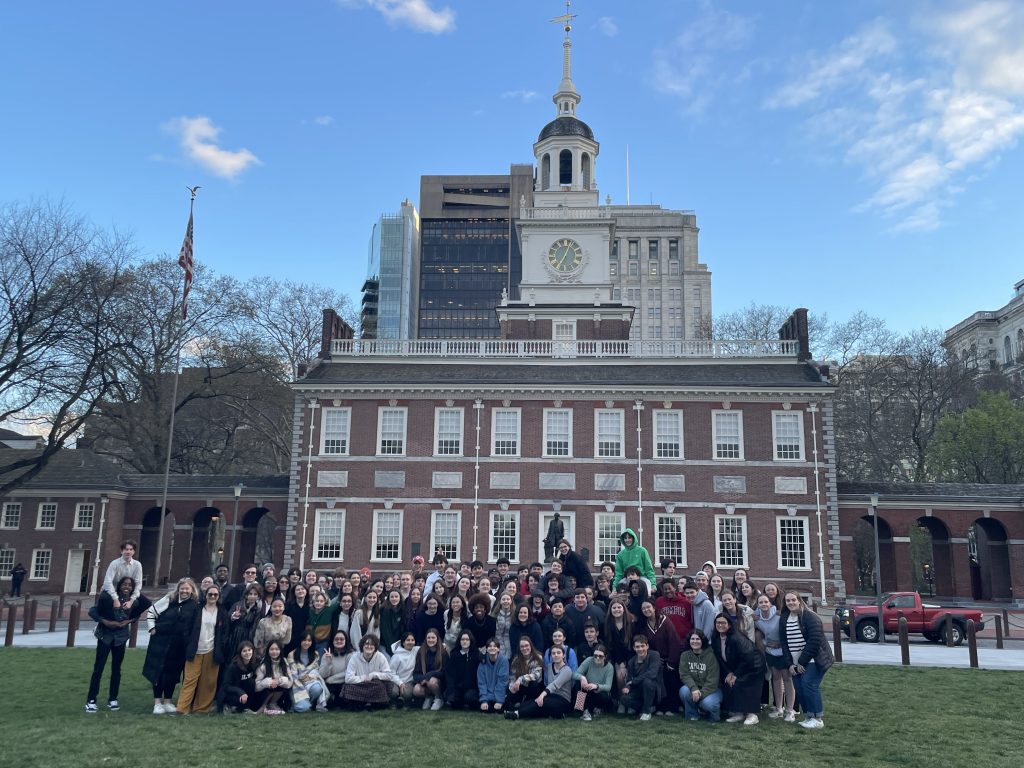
[[418, 217, 521, 339]]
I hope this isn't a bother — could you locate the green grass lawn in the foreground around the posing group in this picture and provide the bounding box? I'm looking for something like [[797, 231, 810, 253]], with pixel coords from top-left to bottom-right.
[[6, 648, 1024, 768]]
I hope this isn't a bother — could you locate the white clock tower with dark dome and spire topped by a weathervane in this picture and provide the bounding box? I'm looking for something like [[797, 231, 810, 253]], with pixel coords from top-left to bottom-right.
[[498, 2, 633, 339]]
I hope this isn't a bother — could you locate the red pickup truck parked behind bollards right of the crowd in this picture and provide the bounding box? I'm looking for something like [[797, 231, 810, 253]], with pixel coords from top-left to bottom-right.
[[836, 592, 985, 645]]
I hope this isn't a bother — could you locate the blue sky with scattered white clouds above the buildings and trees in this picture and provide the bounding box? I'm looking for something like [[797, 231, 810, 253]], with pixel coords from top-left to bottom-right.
[[0, 0, 1024, 330]]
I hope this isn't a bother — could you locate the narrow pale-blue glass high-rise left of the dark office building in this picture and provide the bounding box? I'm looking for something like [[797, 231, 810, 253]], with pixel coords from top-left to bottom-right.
[[360, 200, 420, 339]]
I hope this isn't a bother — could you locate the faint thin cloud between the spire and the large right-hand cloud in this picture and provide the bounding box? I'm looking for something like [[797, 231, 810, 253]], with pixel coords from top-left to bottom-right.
[[651, 5, 754, 114]]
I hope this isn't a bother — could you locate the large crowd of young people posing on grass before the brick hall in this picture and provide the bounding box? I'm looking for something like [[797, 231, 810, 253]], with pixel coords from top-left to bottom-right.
[[86, 529, 833, 729]]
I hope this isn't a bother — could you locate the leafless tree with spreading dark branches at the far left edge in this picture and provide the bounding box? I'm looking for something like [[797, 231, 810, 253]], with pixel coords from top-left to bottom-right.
[[0, 202, 133, 494]]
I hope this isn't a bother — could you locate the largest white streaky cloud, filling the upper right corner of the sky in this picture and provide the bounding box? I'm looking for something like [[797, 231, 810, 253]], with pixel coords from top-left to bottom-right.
[[764, 1, 1024, 230]]
